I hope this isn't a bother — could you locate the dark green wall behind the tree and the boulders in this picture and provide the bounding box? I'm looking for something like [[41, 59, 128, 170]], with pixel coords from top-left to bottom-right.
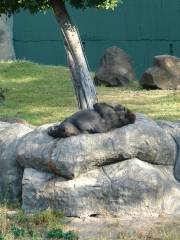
[[14, 0, 180, 77]]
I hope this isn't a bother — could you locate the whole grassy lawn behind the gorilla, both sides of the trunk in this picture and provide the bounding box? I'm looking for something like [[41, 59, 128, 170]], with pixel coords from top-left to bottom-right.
[[0, 61, 180, 125]]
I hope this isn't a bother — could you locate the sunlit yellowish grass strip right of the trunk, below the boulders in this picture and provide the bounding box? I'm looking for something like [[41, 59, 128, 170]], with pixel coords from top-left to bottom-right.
[[99, 87, 180, 121]]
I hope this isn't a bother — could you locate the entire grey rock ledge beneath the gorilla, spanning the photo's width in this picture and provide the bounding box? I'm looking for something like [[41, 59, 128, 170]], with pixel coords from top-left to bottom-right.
[[0, 114, 180, 217]]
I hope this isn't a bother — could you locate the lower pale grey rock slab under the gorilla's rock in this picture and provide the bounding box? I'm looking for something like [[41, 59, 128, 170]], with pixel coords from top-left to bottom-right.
[[22, 159, 180, 217]]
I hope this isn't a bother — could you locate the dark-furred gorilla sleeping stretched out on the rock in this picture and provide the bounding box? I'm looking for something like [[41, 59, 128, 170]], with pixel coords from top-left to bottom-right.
[[48, 103, 136, 138]]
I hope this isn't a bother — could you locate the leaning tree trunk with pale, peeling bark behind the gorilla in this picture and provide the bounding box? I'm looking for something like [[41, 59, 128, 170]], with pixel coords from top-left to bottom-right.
[[51, 0, 97, 109]]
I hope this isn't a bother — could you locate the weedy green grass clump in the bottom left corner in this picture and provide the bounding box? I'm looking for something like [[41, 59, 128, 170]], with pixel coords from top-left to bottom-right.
[[0, 205, 78, 240]]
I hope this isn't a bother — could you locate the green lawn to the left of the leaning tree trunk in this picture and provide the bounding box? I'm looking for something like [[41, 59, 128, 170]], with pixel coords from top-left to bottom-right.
[[0, 62, 76, 125]]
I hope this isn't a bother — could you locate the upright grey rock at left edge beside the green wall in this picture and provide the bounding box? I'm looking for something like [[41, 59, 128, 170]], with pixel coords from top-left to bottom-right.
[[0, 14, 15, 60]]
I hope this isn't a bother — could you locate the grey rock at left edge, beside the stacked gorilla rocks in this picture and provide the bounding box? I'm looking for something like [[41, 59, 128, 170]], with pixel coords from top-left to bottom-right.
[[0, 122, 32, 201]]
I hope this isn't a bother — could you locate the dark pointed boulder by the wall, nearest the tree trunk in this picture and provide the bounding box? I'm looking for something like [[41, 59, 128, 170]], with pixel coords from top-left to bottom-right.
[[94, 47, 135, 86]]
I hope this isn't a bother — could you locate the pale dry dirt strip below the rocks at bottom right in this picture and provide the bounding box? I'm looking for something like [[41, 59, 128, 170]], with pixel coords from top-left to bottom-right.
[[68, 216, 180, 240]]
